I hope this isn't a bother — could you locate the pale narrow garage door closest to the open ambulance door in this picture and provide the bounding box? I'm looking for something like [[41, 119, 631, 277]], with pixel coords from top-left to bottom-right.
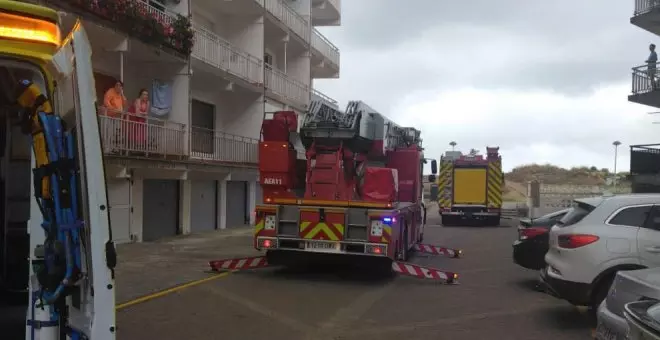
[[108, 179, 131, 243]]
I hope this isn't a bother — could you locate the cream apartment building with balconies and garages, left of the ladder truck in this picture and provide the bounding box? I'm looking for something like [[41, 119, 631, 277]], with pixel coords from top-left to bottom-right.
[[35, 0, 341, 243]]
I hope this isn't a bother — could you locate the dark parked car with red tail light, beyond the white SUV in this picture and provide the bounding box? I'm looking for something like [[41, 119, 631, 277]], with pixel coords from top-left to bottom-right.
[[513, 209, 569, 270]]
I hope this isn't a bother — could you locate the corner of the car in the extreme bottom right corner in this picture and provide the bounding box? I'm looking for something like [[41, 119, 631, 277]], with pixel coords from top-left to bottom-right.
[[624, 301, 660, 340]]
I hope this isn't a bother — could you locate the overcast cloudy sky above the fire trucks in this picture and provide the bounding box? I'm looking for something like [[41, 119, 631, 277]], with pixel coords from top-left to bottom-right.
[[314, 0, 660, 171]]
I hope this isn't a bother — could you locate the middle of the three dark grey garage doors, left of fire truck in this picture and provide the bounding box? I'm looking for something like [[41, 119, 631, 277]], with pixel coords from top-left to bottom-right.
[[190, 181, 217, 233]]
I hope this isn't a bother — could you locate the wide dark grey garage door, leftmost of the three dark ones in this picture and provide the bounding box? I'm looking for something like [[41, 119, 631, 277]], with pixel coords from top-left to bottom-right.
[[142, 179, 179, 241]]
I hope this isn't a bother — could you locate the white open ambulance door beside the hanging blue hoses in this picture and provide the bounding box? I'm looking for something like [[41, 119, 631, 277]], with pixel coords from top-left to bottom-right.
[[30, 21, 116, 340]]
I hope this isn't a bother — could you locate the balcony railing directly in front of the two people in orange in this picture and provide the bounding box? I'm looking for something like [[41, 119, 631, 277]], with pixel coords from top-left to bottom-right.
[[98, 107, 185, 158]]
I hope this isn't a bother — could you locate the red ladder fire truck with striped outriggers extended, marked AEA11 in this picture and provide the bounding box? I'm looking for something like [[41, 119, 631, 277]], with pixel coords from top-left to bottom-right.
[[211, 101, 460, 283]]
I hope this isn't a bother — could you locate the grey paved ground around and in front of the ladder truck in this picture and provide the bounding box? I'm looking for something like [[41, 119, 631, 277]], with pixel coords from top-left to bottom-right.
[[117, 211, 590, 340]]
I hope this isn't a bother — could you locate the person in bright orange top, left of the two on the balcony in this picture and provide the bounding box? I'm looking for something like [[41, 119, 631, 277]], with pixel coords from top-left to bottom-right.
[[101, 80, 127, 152]]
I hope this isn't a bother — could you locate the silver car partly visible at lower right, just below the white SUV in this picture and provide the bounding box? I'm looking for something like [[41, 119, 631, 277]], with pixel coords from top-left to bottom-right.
[[596, 268, 660, 340]]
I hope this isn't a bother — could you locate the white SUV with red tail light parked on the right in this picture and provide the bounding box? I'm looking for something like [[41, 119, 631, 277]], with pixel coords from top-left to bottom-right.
[[541, 194, 660, 310]]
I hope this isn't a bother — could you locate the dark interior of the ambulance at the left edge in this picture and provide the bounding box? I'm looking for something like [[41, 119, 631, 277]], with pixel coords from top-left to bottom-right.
[[0, 58, 46, 339]]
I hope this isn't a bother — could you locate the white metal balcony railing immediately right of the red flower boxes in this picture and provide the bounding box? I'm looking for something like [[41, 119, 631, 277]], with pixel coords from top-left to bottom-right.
[[192, 24, 263, 84]]
